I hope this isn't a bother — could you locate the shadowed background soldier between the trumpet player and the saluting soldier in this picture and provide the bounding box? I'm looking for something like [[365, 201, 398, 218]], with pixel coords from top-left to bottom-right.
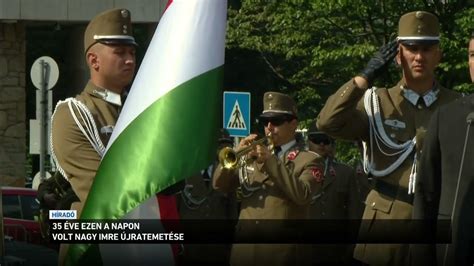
[[308, 124, 363, 265]]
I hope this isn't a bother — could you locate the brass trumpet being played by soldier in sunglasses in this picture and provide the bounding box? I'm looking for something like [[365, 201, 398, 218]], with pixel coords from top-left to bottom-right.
[[219, 132, 273, 170]]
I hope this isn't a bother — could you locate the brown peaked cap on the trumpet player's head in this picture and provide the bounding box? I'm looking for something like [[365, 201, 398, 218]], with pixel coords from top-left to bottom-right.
[[260, 91, 297, 118]]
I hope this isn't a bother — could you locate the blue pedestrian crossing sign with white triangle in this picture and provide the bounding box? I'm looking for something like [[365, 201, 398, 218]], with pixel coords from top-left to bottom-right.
[[223, 91, 250, 137]]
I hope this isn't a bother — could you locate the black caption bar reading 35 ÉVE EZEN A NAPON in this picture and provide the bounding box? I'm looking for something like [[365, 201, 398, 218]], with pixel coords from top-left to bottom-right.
[[50, 219, 451, 244]]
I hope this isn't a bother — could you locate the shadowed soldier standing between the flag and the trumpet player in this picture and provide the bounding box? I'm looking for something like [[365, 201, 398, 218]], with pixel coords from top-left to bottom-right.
[[178, 129, 238, 265]]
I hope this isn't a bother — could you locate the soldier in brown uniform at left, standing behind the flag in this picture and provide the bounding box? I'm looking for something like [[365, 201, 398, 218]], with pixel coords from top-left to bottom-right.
[[51, 9, 137, 264]]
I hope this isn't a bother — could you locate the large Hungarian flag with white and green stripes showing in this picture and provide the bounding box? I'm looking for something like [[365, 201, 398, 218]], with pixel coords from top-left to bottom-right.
[[66, 0, 227, 265]]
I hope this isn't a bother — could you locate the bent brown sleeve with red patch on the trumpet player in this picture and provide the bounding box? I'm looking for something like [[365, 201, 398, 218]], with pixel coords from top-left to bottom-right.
[[263, 153, 324, 205]]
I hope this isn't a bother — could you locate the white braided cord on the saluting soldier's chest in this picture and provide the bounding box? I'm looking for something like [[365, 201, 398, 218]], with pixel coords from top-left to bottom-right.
[[362, 87, 416, 194]]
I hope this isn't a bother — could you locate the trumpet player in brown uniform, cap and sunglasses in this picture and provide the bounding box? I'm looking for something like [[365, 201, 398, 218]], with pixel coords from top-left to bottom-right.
[[213, 92, 324, 266]]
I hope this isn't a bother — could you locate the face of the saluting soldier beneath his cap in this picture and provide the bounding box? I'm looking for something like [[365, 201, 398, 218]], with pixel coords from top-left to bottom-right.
[[397, 44, 441, 81]]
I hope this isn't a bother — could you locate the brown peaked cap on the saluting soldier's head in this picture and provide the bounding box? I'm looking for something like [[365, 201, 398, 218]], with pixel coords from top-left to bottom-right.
[[397, 11, 439, 45]]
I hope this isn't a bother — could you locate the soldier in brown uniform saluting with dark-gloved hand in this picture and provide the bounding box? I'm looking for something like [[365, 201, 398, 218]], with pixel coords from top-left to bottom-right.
[[317, 11, 458, 265]]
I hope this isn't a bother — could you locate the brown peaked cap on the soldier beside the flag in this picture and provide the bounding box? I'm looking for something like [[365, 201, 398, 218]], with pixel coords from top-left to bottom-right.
[[84, 8, 137, 53]]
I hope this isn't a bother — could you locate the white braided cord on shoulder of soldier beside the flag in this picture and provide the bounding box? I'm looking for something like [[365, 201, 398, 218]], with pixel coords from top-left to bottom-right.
[[49, 98, 105, 180]]
